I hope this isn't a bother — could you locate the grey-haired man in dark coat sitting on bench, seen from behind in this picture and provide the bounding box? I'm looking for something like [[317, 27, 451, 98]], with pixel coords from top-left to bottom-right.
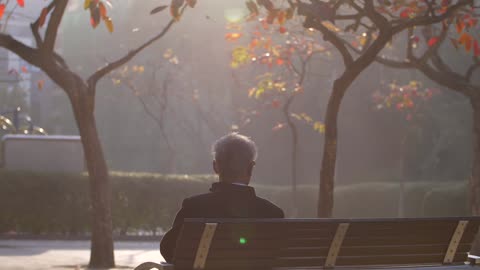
[[160, 133, 284, 263]]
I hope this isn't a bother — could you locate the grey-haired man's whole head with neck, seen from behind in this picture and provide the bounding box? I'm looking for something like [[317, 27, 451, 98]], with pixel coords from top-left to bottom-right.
[[212, 133, 257, 184]]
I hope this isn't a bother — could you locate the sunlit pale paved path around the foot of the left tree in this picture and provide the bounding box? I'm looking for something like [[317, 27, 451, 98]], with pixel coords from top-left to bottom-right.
[[0, 240, 163, 270]]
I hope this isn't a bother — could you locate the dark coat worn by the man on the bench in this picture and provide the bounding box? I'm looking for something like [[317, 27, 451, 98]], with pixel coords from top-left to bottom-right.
[[160, 183, 284, 263]]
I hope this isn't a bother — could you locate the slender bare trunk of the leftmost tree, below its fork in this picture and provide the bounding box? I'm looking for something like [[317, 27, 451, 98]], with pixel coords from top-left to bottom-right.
[[71, 92, 115, 268]]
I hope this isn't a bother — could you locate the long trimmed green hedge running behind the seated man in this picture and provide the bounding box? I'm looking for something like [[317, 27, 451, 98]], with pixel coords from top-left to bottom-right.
[[0, 170, 469, 234]]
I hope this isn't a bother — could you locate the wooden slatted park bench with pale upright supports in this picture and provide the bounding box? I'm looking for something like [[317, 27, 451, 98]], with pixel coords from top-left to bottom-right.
[[135, 217, 480, 270]]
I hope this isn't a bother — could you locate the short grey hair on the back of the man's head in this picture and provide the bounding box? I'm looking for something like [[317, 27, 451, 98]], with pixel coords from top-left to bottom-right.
[[212, 132, 257, 177]]
